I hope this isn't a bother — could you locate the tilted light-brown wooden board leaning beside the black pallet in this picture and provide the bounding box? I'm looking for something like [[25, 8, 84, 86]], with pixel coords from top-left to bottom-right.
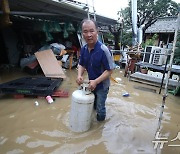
[[35, 49, 66, 78]]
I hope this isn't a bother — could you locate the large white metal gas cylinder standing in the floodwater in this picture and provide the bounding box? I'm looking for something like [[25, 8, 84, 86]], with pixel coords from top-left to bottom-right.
[[70, 83, 94, 132]]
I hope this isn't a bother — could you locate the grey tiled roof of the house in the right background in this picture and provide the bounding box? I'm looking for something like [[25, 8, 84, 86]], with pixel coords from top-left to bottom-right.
[[145, 17, 177, 33]]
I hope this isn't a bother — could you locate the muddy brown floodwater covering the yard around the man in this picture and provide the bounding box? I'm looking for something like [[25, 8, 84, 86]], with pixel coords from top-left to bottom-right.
[[0, 69, 180, 154]]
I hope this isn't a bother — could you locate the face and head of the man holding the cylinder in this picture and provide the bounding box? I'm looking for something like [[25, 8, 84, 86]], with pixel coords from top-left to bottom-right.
[[82, 21, 98, 45]]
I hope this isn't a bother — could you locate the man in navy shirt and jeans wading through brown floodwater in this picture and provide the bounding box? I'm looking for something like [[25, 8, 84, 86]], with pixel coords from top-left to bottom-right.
[[76, 19, 113, 121]]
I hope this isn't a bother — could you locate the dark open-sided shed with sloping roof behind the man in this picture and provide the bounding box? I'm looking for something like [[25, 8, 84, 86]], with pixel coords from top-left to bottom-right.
[[0, 0, 116, 72]]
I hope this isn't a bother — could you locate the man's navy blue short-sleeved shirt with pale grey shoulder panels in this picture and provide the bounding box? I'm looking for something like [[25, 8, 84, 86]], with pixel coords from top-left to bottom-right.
[[79, 41, 113, 89]]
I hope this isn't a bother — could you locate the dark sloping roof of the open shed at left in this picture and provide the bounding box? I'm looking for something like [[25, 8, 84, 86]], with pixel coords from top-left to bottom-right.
[[3, 0, 117, 25]]
